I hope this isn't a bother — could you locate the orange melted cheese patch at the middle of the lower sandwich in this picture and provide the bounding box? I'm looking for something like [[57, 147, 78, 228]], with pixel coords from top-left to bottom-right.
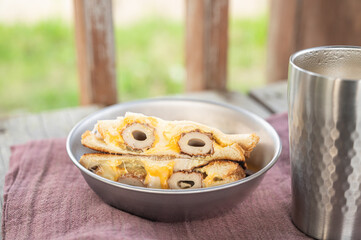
[[143, 161, 174, 189]]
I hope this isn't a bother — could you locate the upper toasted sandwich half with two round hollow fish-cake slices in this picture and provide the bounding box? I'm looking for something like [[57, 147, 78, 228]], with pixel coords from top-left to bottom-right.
[[81, 113, 259, 161]]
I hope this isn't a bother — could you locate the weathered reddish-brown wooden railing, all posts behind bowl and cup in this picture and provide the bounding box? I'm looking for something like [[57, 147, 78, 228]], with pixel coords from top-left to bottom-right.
[[74, 0, 361, 105]]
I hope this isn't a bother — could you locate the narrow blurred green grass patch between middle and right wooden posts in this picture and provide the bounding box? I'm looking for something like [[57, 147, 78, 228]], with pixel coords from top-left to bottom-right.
[[228, 15, 268, 93]]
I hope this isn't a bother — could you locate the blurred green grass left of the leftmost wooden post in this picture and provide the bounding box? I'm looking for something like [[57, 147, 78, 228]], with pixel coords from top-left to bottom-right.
[[0, 20, 78, 113]]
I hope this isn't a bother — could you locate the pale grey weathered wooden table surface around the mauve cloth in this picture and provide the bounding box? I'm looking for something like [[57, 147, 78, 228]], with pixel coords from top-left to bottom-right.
[[0, 82, 287, 235]]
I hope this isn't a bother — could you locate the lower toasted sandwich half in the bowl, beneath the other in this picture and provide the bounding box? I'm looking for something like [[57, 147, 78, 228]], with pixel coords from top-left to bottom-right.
[[80, 153, 245, 189]]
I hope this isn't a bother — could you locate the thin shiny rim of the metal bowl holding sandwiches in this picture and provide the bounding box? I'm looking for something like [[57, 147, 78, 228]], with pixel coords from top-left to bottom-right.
[[66, 97, 282, 194]]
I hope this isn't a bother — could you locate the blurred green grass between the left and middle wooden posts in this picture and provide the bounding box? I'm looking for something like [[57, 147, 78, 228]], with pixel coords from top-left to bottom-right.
[[115, 19, 184, 101]]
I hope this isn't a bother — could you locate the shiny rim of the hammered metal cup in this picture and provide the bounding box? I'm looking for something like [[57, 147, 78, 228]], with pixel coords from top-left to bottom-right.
[[289, 45, 361, 81]]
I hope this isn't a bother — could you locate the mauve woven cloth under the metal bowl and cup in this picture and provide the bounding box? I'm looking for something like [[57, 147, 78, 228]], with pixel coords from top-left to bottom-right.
[[2, 114, 307, 240]]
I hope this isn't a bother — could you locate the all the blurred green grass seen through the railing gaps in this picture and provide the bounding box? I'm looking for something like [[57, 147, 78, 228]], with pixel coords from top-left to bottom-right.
[[0, 16, 267, 115]]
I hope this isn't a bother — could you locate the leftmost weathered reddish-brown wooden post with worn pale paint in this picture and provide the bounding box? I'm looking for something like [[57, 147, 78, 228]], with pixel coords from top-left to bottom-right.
[[74, 0, 117, 105]]
